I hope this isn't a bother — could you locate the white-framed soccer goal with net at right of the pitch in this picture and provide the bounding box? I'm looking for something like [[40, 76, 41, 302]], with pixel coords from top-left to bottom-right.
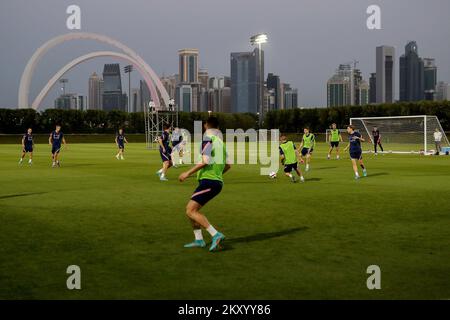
[[350, 115, 450, 154]]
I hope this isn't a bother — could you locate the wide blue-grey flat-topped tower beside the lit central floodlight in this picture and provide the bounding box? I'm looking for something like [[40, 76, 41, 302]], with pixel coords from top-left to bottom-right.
[[231, 49, 264, 113]]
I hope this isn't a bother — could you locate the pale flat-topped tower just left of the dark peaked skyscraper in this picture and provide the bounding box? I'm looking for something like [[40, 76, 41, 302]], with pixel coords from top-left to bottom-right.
[[376, 46, 395, 103]]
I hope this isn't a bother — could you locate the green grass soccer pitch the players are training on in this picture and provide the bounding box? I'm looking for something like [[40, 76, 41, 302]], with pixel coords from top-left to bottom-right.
[[0, 141, 450, 299]]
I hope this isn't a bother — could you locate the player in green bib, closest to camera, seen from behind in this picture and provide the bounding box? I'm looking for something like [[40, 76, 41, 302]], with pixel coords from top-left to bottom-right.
[[178, 117, 231, 251]]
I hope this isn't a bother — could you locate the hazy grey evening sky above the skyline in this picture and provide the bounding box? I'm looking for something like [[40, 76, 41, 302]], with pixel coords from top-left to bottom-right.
[[0, 0, 450, 107]]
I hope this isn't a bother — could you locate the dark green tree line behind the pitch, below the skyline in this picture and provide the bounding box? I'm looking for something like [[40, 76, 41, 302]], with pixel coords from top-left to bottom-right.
[[0, 101, 450, 134]]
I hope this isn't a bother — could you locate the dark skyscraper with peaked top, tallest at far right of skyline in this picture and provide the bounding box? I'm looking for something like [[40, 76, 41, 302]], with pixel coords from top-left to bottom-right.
[[400, 41, 425, 101]]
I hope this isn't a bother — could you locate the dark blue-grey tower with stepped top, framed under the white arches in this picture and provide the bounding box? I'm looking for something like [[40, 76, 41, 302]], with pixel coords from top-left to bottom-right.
[[103, 63, 127, 111]]
